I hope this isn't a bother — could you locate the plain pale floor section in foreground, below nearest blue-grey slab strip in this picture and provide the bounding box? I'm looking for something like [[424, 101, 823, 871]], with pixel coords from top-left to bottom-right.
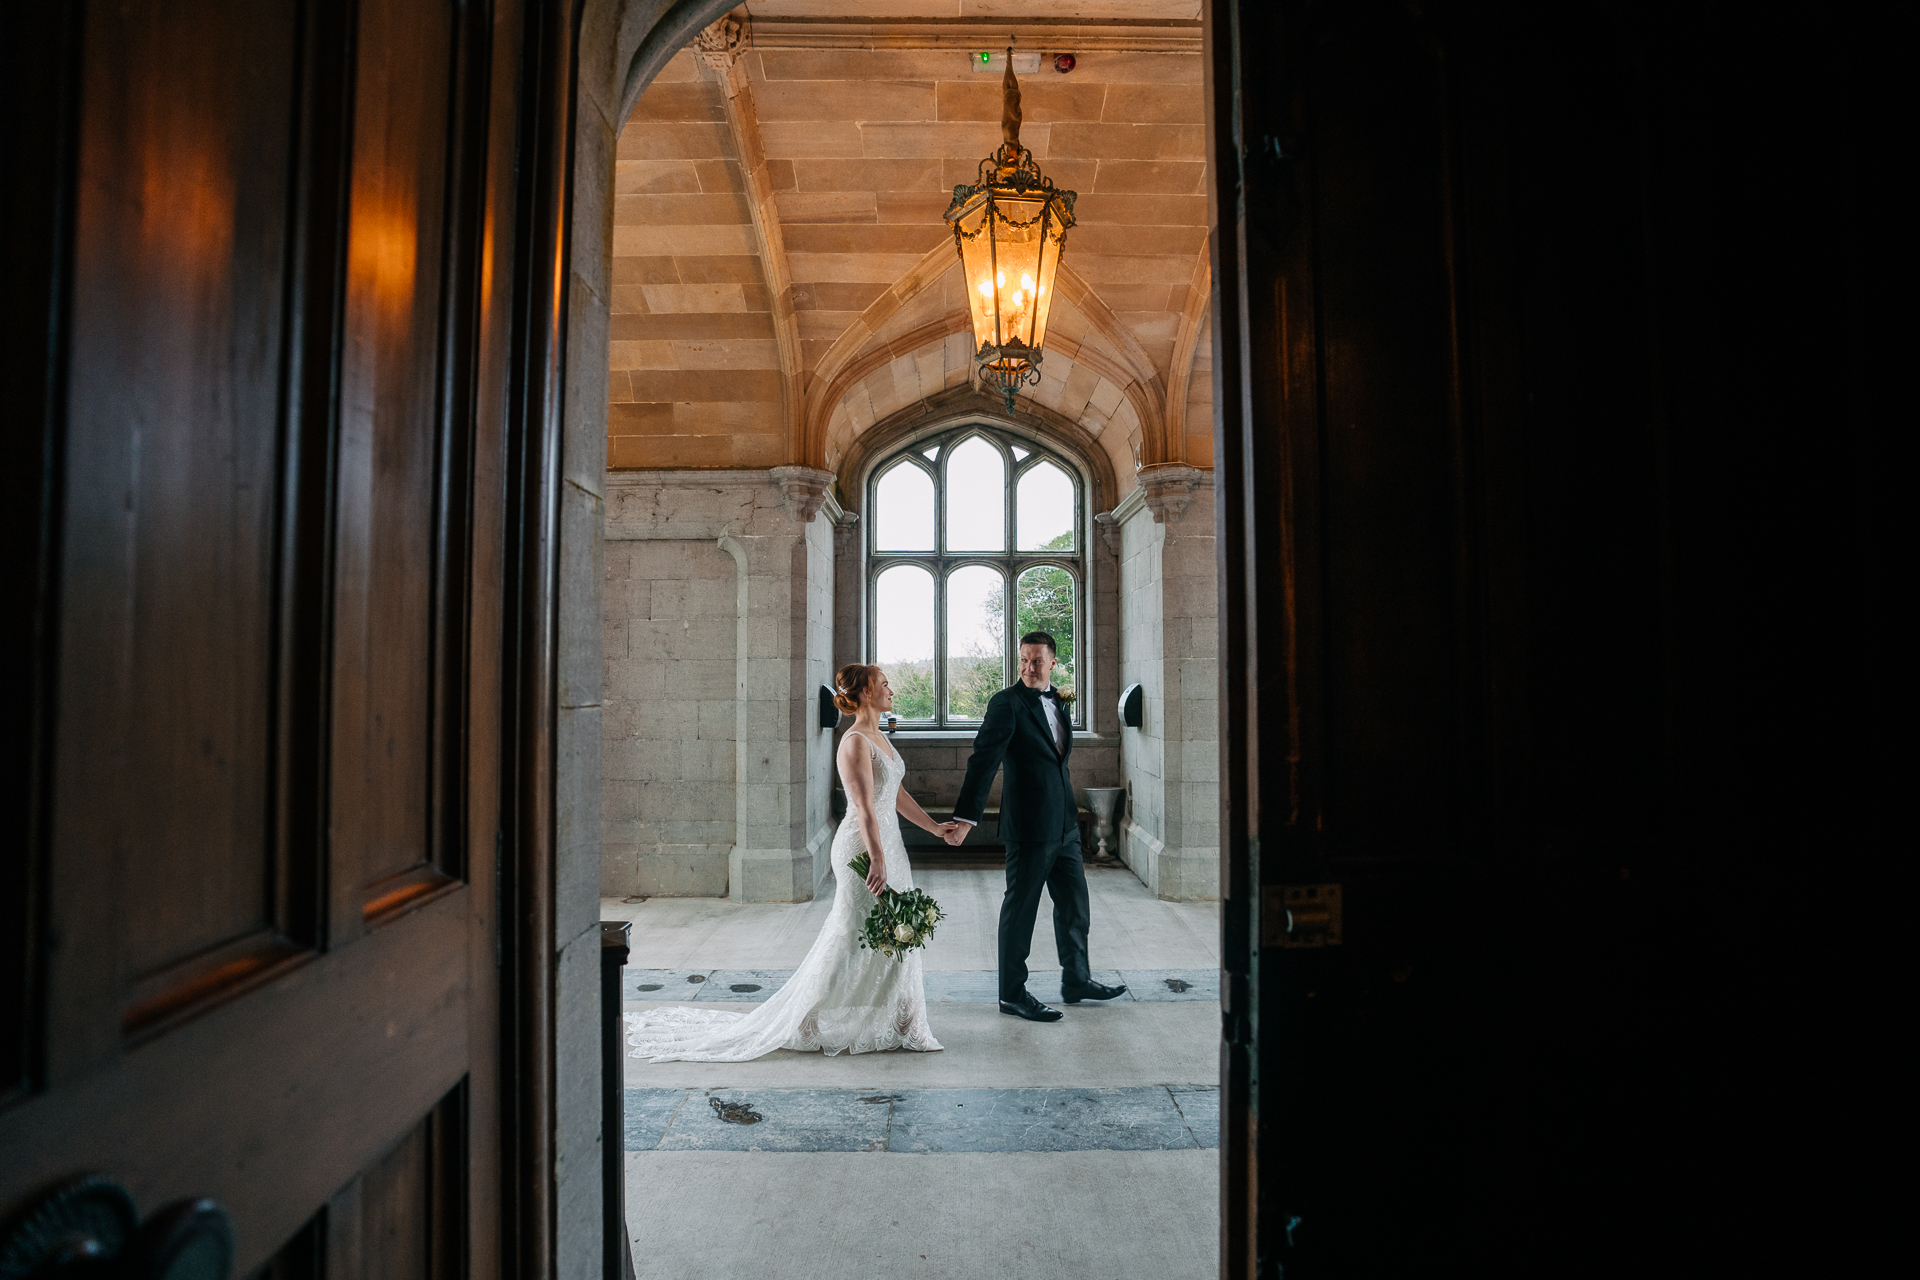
[[626, 1150, 1219, 1280]]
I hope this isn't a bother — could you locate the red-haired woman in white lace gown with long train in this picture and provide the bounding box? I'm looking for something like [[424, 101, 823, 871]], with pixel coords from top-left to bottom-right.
[[626, 662, 952, 1061]]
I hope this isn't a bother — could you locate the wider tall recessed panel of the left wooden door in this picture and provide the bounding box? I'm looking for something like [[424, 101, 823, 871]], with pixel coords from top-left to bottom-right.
[[50, 0, 298, 1071]]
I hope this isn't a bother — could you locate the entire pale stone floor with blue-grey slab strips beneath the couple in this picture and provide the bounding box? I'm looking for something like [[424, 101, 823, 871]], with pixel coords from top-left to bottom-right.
[[601, 867, 1219, 1280]]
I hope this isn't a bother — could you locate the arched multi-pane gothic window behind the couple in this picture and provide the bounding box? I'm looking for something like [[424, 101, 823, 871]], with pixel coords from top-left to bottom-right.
[[866, 424, 1087, 727]]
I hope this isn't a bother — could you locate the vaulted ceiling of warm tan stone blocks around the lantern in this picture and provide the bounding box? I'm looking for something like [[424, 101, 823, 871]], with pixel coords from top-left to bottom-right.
[[609, 0, 1212, 489]]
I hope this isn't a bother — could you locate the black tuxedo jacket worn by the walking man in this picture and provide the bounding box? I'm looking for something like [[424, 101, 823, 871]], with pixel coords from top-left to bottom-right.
[[954, 685, 1079, 844]]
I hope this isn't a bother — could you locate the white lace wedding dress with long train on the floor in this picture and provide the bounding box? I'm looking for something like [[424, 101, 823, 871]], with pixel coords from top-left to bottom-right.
[[626, 733, 941, 1063]]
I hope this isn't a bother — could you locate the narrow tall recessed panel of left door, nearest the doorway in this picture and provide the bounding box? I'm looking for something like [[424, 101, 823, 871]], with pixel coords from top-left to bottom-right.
[[330, 0, 453, 940]]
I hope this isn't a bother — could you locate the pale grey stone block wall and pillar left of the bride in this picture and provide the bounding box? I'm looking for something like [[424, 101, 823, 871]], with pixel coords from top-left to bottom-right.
[[601, 472, 833, 902]]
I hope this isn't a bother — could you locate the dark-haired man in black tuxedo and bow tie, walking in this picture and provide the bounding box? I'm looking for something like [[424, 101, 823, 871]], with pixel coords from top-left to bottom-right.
[[947, 631, 1127, 1023]]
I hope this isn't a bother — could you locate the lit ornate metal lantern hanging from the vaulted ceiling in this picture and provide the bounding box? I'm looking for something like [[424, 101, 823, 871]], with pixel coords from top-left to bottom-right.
[[947, 48, 1075, 413]]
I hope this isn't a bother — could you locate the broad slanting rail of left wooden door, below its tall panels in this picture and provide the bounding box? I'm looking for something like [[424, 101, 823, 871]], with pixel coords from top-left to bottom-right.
[[0, 889, 472, 1274]]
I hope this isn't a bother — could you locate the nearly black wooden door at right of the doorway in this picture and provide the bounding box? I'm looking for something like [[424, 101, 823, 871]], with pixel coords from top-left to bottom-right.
[[1206, 0, 1873, 1280]]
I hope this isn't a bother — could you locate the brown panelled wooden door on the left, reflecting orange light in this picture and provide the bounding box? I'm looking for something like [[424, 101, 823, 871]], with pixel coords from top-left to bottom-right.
[[0, 0, 551, 1276]]
